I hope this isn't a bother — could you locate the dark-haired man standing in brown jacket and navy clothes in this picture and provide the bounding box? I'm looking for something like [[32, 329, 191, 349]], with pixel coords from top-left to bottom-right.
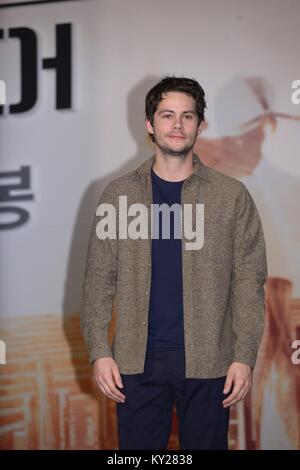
[[81, 77, 267, 449]]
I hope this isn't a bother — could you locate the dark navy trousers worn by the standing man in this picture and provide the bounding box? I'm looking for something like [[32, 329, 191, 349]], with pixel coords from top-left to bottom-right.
[[116, 349, 230, 450]]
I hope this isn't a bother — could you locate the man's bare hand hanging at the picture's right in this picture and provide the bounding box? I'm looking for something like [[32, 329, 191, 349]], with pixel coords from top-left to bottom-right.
[[223, 362, 252, 408]]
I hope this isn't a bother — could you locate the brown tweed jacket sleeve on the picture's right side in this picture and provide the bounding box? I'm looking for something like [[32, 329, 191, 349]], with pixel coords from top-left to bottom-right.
[[231, 183, 268, 368]]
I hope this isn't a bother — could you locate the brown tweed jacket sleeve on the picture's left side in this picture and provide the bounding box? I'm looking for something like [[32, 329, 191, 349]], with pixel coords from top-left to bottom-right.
[[80, 184, 117, 363]]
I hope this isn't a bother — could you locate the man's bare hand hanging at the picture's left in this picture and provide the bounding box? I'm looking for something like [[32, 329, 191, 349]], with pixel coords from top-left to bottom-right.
[[93, 357, 125, 403]]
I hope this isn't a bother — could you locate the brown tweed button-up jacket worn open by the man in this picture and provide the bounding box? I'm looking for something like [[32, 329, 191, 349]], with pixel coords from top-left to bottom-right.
[[80, 154, 267, 378]]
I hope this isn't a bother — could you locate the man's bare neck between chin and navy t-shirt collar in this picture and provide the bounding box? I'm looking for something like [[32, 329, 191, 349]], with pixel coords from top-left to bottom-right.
[[152, 152, 194, 181]]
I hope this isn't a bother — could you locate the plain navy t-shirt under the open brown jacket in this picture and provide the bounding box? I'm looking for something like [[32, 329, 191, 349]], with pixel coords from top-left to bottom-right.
[[147, 168, 184, 350]]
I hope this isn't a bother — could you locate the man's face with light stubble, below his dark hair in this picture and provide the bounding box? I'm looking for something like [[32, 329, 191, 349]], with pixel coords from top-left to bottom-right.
[[146, 91, 201, 156]]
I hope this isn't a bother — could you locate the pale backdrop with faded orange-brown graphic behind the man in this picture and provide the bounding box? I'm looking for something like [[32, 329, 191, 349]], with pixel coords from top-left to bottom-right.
[[0, 0, 300, 449]]
